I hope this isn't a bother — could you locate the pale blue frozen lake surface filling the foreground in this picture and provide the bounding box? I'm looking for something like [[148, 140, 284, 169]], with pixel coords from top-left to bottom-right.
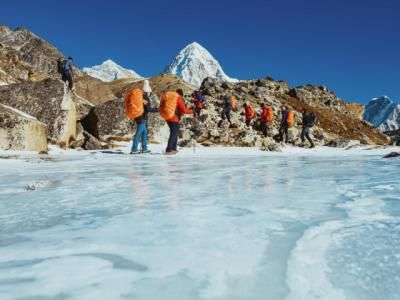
[[0, 148, 400, 300]]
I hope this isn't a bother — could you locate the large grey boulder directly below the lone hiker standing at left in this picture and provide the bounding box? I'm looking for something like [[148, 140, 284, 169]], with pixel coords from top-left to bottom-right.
[[0, 79, 77, 147]]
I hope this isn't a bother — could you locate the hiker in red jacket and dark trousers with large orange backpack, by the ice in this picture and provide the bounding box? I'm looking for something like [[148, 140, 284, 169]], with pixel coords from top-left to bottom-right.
[[160, 89, 193, 155]]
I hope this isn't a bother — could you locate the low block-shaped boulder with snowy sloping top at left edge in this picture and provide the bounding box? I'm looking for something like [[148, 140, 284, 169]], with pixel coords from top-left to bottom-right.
[[0, 104, 47, 152]]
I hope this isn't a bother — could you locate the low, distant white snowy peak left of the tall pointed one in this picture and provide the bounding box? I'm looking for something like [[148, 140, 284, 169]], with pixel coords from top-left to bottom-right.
[[83, 59, 142, 82]]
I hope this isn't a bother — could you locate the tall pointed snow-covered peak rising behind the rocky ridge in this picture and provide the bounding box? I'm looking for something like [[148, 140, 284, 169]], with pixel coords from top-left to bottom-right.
[[165, 42, 237, 87]]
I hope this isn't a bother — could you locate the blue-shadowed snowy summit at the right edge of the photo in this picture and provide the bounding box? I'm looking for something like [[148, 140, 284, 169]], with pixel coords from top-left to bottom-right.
[[364, 96, 400, 131]]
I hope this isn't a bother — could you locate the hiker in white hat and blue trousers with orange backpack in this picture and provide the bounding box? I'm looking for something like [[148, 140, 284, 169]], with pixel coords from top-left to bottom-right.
[[125, 80, 158, 154]]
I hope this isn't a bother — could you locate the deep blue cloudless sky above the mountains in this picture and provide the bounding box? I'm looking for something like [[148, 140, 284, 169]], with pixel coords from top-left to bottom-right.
[[0, 0, 400, 103]]
